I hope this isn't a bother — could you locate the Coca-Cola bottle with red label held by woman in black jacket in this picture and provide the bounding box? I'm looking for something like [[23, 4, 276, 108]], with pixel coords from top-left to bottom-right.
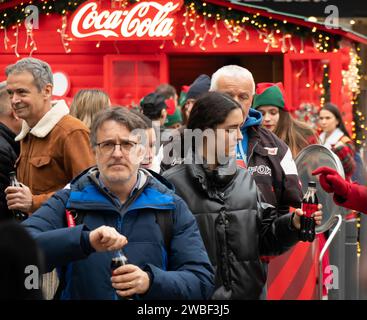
[[299, 181, 319, 242]]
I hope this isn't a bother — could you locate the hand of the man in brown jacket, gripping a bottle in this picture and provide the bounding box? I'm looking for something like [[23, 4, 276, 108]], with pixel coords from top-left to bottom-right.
[[5, 184, 33, 212]]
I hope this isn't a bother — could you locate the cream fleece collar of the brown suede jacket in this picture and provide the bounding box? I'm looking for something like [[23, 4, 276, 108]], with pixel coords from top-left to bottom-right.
[[15, 100, 69, 141]]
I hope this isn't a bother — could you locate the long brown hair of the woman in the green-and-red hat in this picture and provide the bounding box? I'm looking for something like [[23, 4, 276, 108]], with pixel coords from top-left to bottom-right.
[[274, 109, 318, 157]]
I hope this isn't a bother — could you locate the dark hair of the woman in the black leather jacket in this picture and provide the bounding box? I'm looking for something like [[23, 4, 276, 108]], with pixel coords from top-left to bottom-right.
[[187, 92, 241, 130]]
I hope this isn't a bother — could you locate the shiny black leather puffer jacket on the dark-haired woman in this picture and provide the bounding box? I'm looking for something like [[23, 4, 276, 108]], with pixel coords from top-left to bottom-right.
[[163, 164, 298, 299]]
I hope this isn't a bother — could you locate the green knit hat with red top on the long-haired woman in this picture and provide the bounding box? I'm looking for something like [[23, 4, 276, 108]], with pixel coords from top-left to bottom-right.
[[252, 83, 285, 109]]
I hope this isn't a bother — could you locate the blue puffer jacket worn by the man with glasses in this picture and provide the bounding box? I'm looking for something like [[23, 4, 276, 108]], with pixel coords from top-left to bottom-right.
[[24, 169, 214, 299]]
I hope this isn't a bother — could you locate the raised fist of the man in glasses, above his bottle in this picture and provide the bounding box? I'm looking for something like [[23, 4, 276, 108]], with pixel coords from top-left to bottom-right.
[[89, 226, 127, 252]]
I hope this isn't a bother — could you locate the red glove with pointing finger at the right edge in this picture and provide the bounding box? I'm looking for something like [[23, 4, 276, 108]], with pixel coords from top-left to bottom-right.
[[312, 167, 349, 198]]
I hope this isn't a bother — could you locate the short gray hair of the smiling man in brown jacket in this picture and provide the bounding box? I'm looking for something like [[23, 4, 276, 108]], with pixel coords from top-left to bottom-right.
[[5, 58, 54, 91]]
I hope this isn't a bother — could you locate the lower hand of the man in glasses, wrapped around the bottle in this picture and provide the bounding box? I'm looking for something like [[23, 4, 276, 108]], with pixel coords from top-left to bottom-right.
[[111, 264, 150, 298]]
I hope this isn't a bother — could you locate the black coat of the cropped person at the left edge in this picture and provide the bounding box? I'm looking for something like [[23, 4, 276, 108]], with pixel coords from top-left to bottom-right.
[[0, 122, 20, 221]]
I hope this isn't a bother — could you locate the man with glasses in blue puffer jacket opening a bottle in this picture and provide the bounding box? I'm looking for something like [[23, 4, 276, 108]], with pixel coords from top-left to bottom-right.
[[24, 107, 214, 300]]
